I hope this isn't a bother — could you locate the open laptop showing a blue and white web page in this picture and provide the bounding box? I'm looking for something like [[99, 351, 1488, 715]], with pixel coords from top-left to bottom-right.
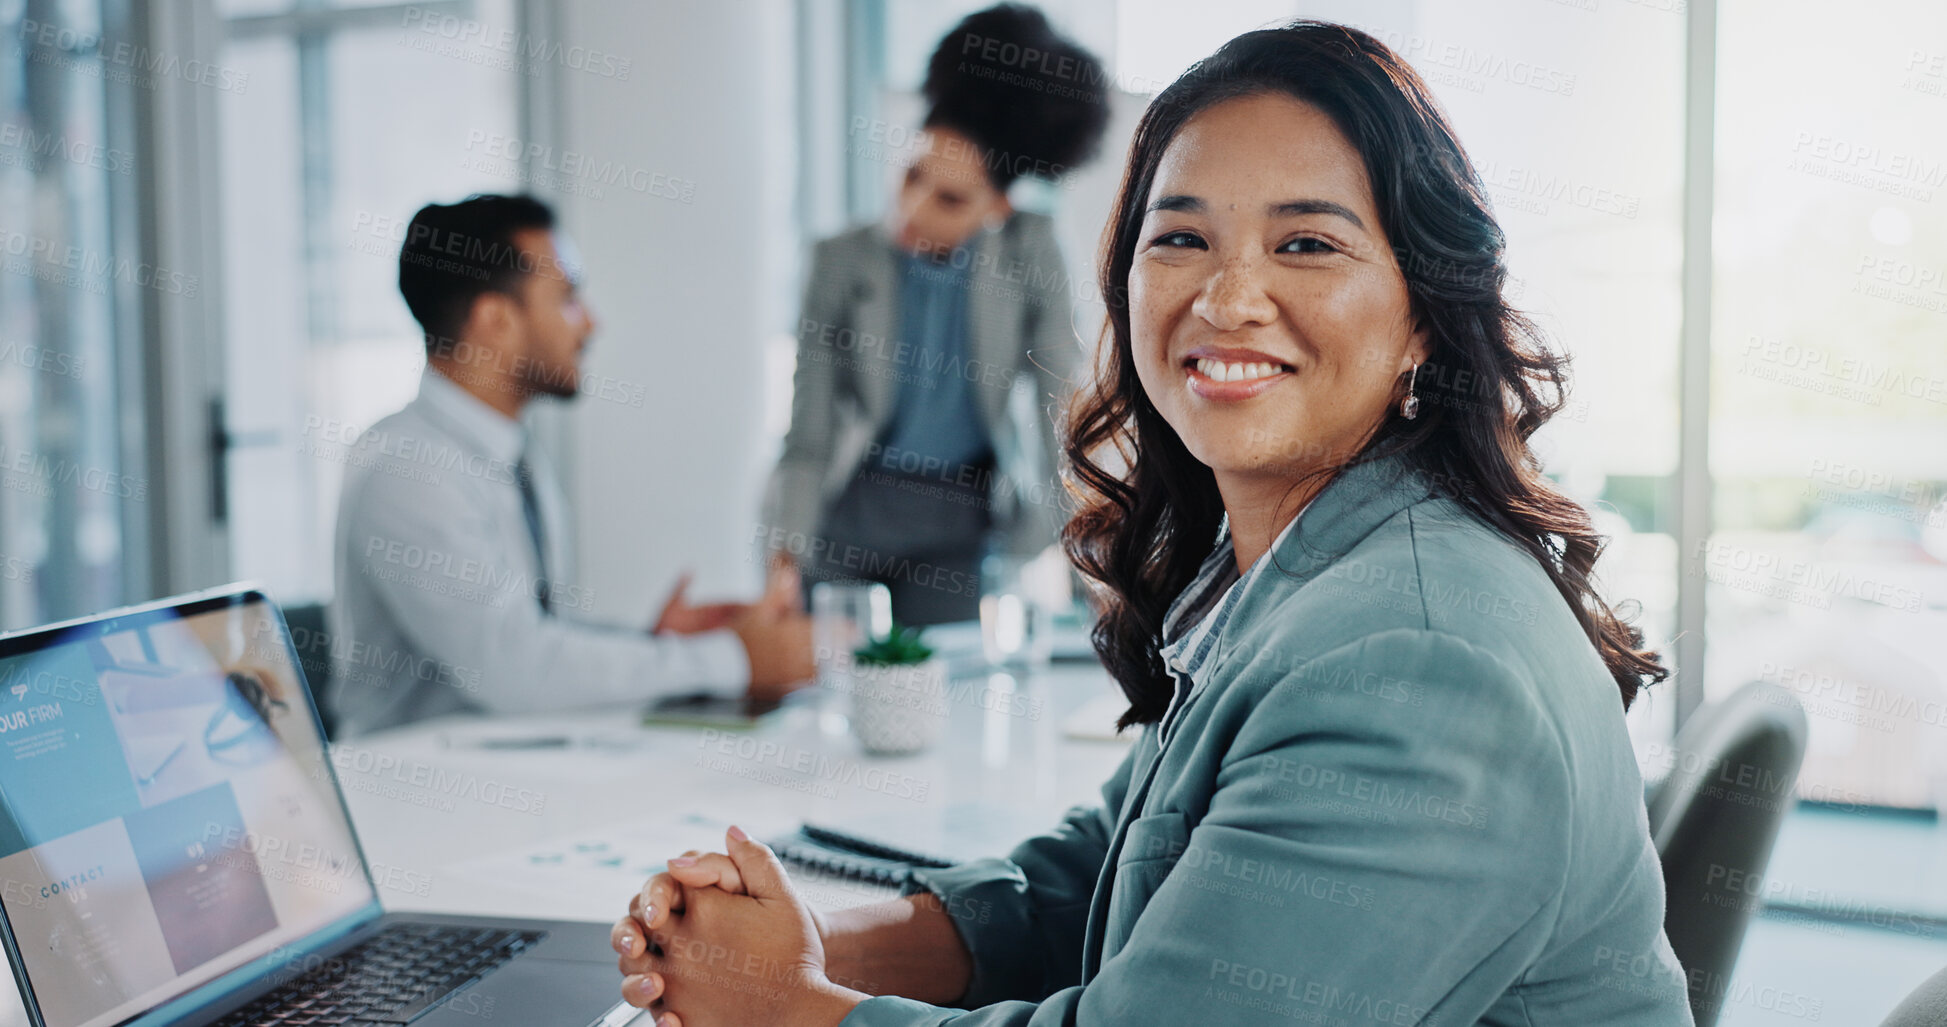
[[0, 587, 639, 1027]]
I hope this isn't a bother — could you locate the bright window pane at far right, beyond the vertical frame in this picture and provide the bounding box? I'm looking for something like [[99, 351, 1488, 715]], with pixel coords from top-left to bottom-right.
[[1713, 0, 1947, 809]]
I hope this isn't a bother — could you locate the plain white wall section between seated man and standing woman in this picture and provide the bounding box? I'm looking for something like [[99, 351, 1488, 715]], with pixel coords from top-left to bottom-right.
[[555, 0, 798, 624]]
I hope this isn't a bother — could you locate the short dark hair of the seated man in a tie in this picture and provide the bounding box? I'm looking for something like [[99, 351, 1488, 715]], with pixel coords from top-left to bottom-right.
[[399, 193, 559, 355]]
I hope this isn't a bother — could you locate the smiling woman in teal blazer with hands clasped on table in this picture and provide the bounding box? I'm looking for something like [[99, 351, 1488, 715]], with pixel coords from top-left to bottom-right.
[[615, 21, 1692, 1027]]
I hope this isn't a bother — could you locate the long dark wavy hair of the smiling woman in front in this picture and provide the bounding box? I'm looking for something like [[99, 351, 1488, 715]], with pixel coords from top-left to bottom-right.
[[1063, 21, 1667, 727]]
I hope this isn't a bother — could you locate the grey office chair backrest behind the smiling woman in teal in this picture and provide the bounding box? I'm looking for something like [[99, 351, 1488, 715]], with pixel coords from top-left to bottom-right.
[[1649, 682, 1807, 1027]]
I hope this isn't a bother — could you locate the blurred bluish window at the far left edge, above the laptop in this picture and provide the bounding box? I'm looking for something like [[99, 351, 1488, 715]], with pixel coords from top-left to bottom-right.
[[0, 2, 150, 629]]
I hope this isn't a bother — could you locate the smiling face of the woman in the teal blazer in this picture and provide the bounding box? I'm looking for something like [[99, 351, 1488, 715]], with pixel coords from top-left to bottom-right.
[[1129, 94, 1427, 481]]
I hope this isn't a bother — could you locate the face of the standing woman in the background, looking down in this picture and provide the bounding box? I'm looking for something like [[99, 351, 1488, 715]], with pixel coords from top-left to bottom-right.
[[892, 127, 1012, 253]]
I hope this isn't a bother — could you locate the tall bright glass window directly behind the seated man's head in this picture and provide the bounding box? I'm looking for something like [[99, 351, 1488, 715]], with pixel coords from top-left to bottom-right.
[[220, 0, 525, 602]]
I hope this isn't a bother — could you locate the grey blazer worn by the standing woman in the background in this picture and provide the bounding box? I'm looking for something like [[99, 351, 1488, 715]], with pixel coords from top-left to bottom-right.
[[761, 212, 1081, 553]]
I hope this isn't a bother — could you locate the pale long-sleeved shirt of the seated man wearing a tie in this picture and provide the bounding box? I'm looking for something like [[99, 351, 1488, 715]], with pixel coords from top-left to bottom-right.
[[317, 368, 750, 737]]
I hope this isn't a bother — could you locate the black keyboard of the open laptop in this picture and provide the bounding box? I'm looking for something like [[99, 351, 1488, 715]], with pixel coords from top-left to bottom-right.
[[212, 924, 547, 1027]]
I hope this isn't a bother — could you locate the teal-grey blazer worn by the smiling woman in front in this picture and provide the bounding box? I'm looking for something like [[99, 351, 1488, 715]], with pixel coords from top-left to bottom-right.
[[845, 460, 1690, 1027]]
